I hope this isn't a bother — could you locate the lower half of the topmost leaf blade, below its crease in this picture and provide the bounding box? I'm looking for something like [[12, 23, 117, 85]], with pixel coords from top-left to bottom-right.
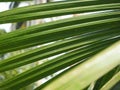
[[0, 0, 120, 24]]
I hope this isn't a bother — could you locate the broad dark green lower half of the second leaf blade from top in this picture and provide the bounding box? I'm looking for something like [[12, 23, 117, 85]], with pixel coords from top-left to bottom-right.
[[0, 17, 120, 53]]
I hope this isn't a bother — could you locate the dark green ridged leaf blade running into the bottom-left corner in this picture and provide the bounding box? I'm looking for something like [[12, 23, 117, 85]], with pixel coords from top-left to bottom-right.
[[1, 39, 119, 90]]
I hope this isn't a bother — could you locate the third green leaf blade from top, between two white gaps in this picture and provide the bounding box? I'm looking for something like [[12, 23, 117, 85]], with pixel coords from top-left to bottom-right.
[[0, 27, 120, 72]]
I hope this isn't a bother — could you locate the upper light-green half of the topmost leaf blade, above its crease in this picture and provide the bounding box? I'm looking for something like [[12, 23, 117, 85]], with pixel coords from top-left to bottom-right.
[[0, 0, 120, 17]]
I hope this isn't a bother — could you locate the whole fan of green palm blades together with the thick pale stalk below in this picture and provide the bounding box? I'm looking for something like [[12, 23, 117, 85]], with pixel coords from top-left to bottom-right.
[[0, 0, 120, 90]]
